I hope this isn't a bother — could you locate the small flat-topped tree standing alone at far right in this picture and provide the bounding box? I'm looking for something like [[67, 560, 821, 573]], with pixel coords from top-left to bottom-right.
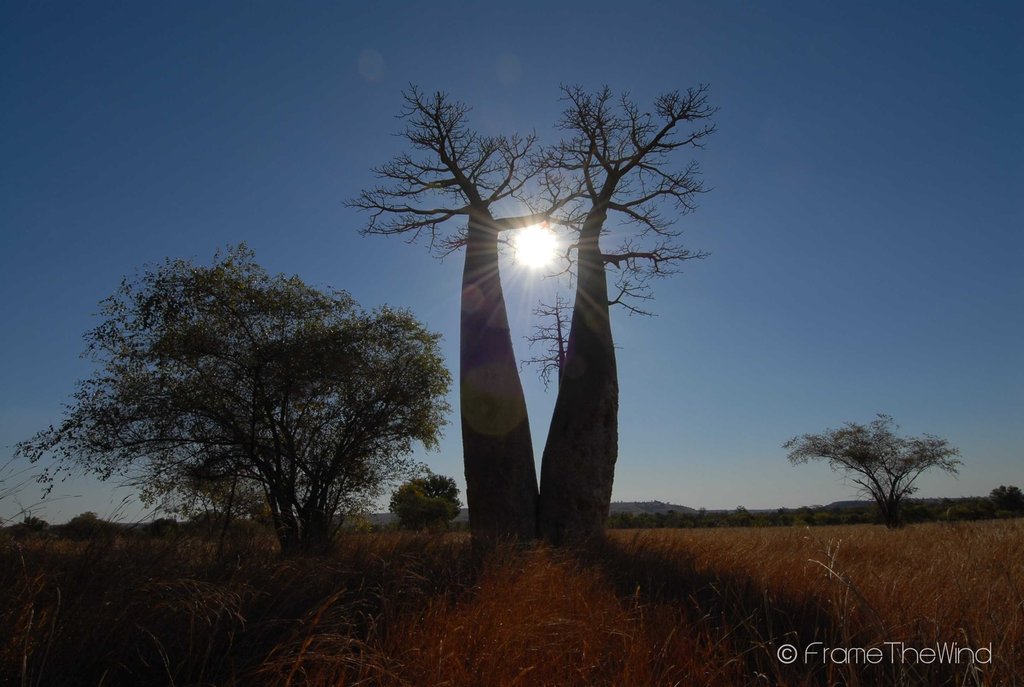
[[782, 414, 962, 527]]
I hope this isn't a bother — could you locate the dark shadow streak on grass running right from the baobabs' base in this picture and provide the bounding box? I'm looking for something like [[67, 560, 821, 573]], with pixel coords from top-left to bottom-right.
[[577, 536, 971, 685]]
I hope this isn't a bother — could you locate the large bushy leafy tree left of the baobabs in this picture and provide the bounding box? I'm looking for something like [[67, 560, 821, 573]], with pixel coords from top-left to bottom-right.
[[17, 246, 450, 552]]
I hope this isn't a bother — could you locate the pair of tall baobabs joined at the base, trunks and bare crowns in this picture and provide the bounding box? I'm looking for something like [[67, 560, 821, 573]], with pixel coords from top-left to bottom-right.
[[352, 85, 714, 544]]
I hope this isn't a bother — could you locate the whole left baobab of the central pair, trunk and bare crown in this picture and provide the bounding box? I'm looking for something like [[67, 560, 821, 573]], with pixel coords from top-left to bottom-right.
[[349, 87, 575, 540]]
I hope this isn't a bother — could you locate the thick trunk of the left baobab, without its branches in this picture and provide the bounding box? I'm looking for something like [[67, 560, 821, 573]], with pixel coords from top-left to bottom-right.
[[459, 217, 538, 542]]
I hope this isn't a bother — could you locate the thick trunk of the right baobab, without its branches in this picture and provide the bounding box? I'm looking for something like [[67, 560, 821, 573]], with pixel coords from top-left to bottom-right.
[[539, 211, 618, 545]]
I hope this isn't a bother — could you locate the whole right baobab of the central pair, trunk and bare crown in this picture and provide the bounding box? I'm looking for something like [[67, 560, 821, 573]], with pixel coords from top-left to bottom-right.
[[539, 85, 715, 544]]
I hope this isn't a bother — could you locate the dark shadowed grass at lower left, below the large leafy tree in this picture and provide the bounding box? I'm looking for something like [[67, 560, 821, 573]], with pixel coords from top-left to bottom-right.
[[0, 535, 479, 685]]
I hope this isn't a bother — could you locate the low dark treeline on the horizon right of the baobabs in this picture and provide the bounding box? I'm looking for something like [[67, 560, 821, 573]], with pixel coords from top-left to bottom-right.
[[608, 497, 1024, 529]]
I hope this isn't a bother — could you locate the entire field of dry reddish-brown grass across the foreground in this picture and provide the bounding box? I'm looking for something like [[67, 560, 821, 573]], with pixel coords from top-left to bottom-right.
[[0, 519, 1024, 687]]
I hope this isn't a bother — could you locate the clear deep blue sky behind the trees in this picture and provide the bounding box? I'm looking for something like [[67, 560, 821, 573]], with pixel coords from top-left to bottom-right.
[[0, 0, 1024, 521]]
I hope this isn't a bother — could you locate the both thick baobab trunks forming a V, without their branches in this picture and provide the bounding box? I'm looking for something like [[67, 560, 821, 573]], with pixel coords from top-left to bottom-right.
[[460, 213, 618, 545]]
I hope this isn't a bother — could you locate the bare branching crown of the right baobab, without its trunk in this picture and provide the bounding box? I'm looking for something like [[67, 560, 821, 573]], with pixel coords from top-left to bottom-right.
[[548, 85, 715, 312]]
